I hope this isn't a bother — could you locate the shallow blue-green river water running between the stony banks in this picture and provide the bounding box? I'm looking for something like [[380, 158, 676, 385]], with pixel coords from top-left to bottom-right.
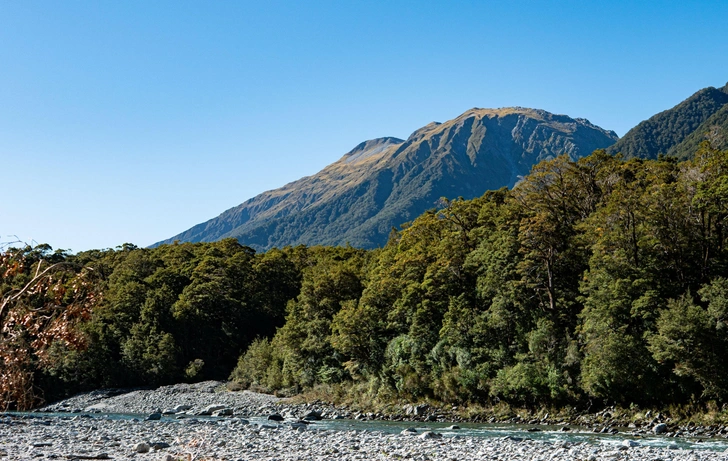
[[7, 412, 728, 451]]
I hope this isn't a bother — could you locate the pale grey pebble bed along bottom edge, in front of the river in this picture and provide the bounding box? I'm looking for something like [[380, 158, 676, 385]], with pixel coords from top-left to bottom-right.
[[0, 417, 725, 461]]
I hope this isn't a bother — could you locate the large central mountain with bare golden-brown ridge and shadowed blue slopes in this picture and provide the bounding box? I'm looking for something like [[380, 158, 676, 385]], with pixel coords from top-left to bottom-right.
[[155, 107, 618, 250]]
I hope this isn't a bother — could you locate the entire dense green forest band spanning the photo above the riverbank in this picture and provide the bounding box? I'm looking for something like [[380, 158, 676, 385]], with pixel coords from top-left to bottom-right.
[[0, 143, 728, 408]]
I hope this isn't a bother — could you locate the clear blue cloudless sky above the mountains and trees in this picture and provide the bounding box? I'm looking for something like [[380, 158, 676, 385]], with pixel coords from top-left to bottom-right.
[[0, 0, 728, 252]]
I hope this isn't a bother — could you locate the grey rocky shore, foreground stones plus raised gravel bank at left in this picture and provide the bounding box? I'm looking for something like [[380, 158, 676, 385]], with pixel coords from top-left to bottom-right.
[[0, 382, 728, 461]]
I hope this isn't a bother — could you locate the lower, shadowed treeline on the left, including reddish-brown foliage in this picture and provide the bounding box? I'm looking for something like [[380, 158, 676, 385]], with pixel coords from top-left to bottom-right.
[[0, 239, 316, 409]]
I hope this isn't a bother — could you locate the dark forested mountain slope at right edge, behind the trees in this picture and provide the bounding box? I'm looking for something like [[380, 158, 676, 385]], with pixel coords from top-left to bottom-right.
[[607, 84, 728, 159]]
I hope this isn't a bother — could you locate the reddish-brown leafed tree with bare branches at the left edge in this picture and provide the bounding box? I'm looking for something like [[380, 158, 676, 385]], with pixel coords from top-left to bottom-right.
[[0, 245, 98, 410]]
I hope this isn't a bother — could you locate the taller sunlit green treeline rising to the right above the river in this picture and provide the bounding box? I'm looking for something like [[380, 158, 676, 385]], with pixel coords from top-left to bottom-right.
[[233, 145, 728, 405]]
